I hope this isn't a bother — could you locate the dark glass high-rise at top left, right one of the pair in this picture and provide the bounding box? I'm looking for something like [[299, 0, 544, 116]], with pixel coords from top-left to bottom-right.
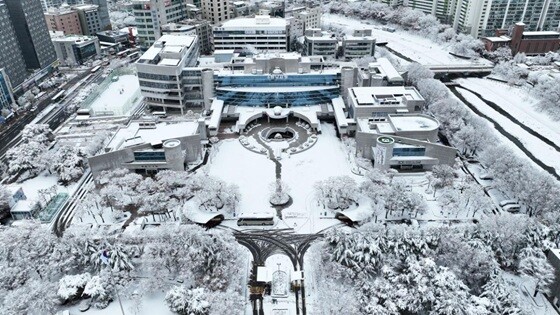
[[4, 0, 56, 73]]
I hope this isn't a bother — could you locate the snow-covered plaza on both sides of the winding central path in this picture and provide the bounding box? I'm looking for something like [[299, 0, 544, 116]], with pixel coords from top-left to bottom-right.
[[209, 124, 360, 233]]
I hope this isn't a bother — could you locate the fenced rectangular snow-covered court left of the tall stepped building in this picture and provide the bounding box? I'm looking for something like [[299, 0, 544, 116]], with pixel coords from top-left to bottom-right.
[[86, 74, 141, 115]]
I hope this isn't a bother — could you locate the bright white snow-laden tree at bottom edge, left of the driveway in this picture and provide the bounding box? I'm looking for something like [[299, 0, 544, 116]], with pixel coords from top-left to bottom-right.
[[165, 286, 210, 315]]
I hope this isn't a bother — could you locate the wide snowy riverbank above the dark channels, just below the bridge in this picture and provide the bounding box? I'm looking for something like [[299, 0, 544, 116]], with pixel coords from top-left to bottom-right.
[[456, 78, 560, 145]]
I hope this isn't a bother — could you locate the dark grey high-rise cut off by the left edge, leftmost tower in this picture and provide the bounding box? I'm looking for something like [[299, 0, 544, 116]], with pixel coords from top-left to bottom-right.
[[0, 0, 27, 87]]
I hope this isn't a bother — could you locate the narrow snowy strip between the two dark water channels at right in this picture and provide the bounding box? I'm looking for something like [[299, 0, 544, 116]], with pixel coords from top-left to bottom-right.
[[457, 88, 560, 173]]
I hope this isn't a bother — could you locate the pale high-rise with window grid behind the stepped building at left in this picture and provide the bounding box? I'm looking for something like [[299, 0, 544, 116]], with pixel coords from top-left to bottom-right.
[[132, 0, 194, 49]]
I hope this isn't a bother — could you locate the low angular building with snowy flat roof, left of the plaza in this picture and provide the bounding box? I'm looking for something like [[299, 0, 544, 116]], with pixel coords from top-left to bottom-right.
[[88, 119, 206, 177]]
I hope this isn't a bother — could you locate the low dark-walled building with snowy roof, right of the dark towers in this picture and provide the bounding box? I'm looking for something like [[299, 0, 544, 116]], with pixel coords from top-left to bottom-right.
[[52, 35, 101, 66]]
